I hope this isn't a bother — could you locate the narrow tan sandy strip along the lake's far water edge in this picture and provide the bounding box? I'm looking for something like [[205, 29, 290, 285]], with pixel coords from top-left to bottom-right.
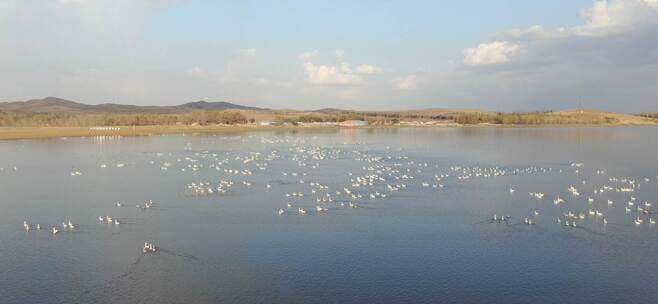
[[0, 123, 658, 140]]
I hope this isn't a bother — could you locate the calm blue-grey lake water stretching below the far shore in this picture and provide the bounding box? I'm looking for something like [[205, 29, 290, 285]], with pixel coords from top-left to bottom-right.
[[0, 128, 658, 303]]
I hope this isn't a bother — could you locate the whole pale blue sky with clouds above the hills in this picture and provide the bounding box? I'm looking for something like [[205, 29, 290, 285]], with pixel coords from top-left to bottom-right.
[[0, 0, 658, 112]]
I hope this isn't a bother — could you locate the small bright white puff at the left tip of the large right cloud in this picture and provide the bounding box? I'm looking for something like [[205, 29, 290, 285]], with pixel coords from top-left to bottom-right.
[[464, 41, 521, 66]]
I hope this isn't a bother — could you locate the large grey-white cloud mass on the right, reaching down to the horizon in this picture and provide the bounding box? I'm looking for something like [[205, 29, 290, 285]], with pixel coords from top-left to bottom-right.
[[446, 0, 658, 112]]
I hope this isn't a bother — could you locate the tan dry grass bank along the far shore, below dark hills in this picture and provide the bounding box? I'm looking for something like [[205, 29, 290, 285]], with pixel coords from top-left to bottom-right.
[[0, 109, 658, 140]]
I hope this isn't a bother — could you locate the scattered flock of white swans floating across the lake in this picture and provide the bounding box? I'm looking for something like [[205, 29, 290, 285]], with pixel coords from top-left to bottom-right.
[[13, 135, 658, 253]]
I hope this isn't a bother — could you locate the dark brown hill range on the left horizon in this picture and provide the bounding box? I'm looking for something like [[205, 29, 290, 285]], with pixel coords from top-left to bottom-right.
[[0, 97, 265, 114]]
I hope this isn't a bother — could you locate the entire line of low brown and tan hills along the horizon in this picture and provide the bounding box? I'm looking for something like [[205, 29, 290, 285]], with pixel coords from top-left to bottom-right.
[[0, 97, 658, 126]]
